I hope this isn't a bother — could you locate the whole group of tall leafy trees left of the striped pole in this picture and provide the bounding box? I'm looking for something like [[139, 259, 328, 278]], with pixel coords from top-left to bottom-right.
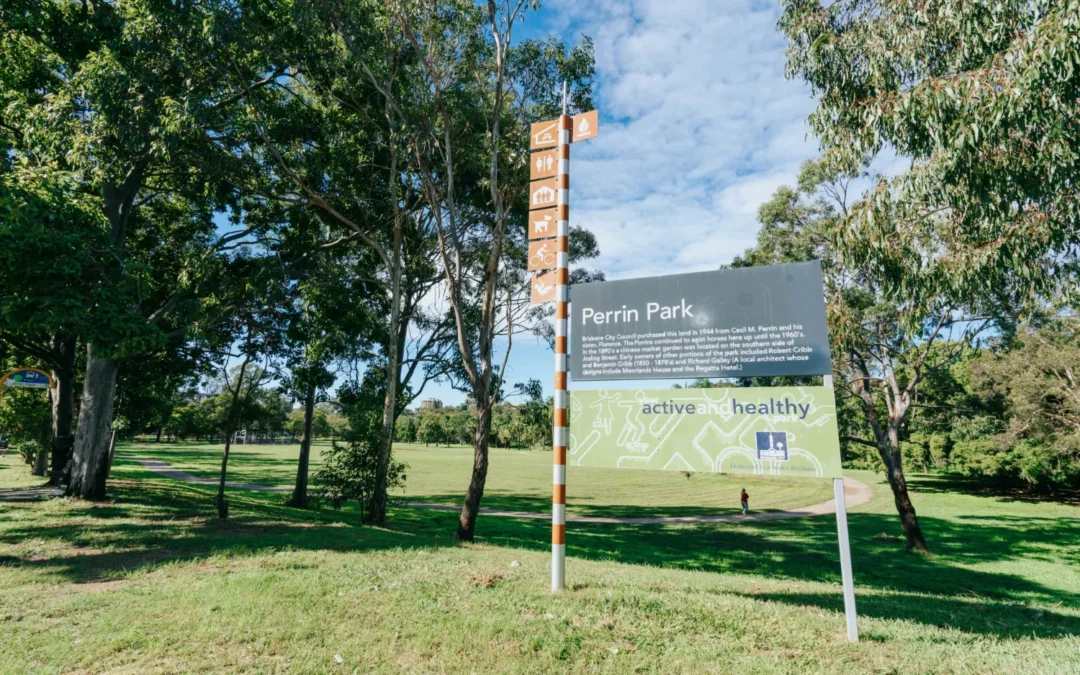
[[0, 0, 602, 539]]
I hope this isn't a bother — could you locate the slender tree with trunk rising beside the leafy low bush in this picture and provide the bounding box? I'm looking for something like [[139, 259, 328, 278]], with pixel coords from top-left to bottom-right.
[[233, 0, 453, 524]]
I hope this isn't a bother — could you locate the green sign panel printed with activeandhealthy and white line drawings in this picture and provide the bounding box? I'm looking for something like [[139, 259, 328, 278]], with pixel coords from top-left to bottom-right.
[[568, 387, 842, 478]]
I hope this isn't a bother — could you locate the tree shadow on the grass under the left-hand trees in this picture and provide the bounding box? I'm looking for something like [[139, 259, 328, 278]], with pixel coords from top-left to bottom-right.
[[0, 480, 453, 583]]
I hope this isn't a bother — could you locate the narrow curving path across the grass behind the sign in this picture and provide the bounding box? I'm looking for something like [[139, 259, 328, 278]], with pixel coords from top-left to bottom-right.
[[124, 455, 874, 525]]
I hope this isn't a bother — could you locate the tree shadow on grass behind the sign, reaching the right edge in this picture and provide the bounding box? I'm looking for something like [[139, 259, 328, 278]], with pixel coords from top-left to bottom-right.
[[429, 505, 1080, 637]]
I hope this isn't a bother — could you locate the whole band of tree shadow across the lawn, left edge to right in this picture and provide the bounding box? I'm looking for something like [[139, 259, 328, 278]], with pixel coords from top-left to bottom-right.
[[0, 464, 1080, 637]]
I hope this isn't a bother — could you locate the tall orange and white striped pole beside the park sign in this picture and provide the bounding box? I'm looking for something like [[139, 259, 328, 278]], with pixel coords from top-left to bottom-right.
[[551, 93, 572, 593]]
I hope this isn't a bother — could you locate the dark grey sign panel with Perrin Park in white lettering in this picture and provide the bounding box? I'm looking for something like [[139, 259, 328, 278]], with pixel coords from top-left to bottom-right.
[[570, 260, 833, 381]]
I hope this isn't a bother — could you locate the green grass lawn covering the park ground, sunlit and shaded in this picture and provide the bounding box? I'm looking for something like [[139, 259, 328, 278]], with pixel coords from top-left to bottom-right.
[[0, 448, 1080, 674]]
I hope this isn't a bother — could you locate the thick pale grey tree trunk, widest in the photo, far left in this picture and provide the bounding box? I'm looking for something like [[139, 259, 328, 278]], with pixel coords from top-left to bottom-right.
[[67, 343, 119, 500]]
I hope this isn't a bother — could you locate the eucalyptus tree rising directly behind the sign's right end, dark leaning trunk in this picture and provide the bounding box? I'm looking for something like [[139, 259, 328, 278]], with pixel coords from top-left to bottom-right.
[[733, 161, 1011, 551]]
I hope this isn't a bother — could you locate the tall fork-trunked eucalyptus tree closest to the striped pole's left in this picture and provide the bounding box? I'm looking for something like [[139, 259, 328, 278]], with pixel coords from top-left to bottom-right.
[[378, 0, 595, 540]]
